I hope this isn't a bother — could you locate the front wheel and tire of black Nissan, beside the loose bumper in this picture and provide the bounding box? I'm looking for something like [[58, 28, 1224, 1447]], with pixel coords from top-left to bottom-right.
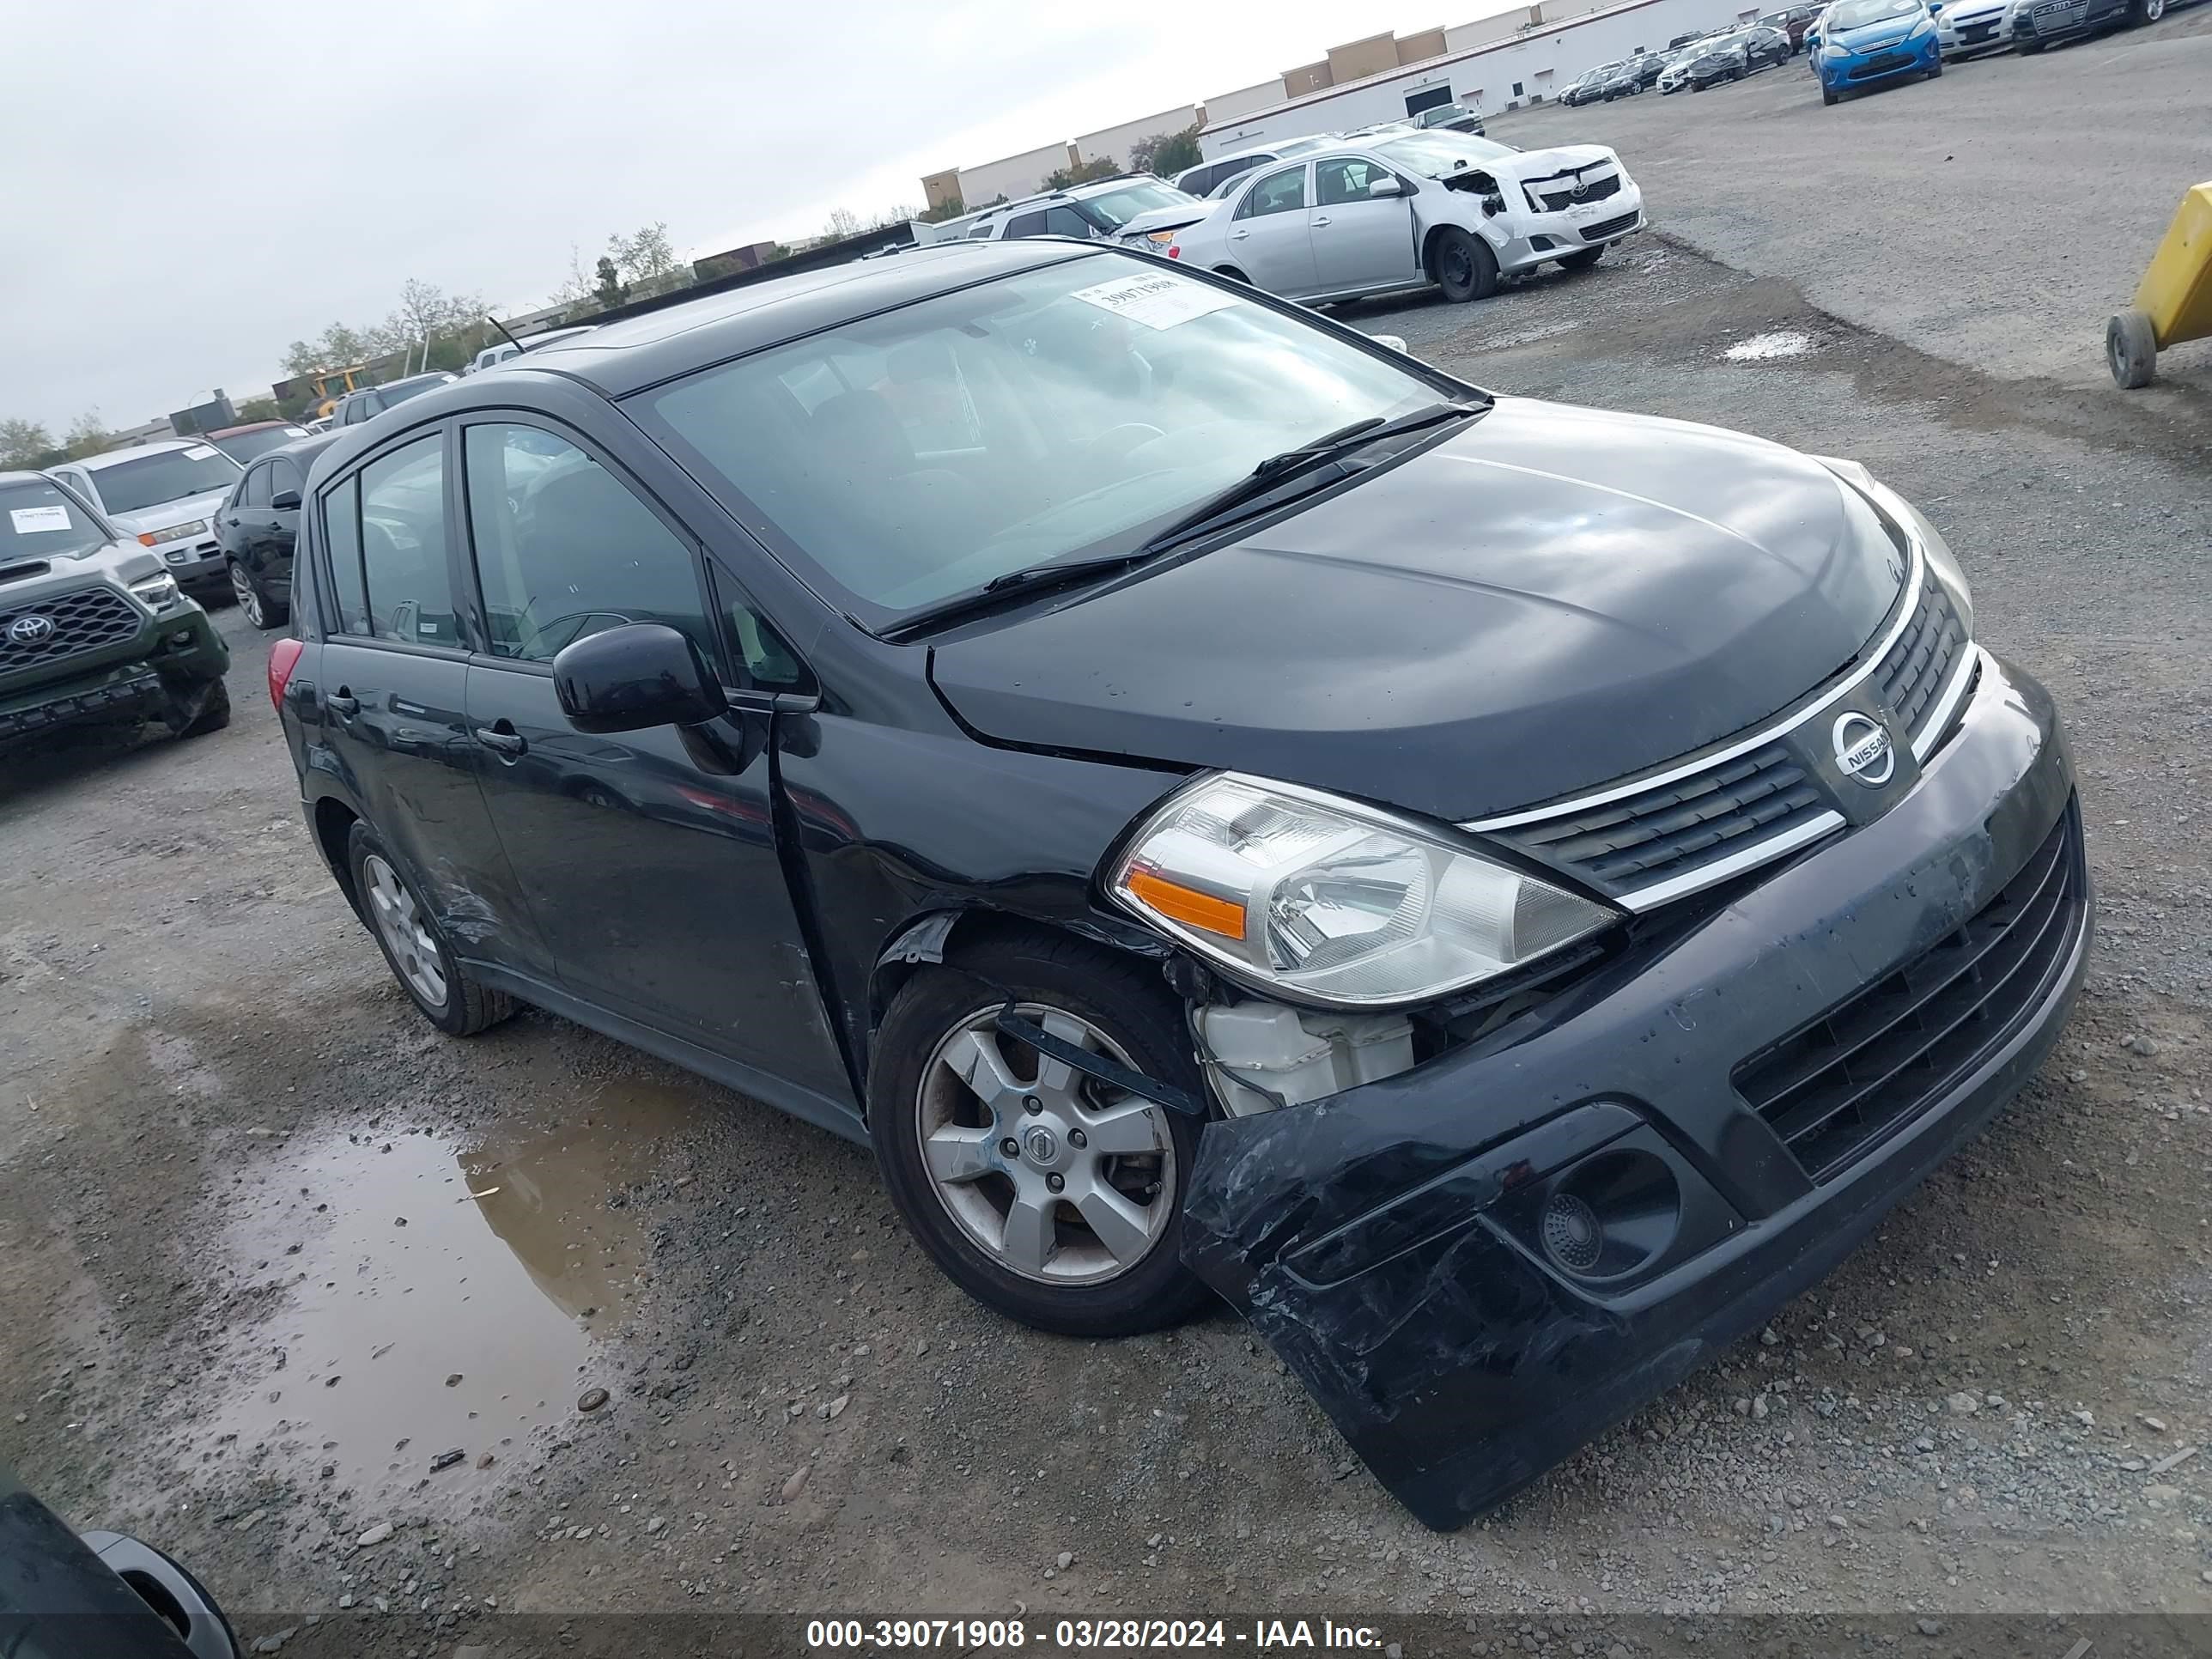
[[867, 933, 1207, 1338]]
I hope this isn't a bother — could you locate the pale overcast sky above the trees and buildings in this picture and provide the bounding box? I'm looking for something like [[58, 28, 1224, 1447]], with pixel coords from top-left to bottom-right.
[[0, 0, 1509, 435]]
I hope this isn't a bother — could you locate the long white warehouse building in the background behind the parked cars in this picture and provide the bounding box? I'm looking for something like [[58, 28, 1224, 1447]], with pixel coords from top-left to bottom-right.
[[1199, 0, 1777, 161]]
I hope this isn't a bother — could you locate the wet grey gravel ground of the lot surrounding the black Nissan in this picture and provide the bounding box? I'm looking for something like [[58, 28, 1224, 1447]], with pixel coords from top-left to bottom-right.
[[0, 45, 2212, 1655]]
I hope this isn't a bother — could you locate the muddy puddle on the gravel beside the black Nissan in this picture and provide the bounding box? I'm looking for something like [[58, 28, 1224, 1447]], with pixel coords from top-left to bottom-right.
[[192, 1084, 706, 1498]]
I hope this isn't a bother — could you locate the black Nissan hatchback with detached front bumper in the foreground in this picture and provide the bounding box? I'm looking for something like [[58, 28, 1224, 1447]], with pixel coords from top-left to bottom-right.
[[270, 241, 2090, 1526]]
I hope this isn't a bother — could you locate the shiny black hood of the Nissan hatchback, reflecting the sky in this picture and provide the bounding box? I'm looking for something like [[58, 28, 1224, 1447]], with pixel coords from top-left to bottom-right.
[[931, 398, 1905, 818]]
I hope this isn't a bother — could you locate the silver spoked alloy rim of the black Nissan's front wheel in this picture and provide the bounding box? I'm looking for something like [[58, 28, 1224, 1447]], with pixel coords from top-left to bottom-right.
[[914, 1002, 1176, 1285]]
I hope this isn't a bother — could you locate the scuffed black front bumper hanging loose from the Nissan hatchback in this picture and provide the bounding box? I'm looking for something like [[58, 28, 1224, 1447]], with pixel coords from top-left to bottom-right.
[[1183, 654, 2093, 1528]]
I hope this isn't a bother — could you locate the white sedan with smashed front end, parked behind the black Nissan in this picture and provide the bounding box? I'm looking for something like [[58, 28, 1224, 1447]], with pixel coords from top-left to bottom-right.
[[1121, 133, 1644, 303]]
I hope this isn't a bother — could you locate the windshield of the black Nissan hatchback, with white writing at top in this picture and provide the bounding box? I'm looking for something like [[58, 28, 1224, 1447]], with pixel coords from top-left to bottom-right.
[[626, 254, 1437, 623]]
